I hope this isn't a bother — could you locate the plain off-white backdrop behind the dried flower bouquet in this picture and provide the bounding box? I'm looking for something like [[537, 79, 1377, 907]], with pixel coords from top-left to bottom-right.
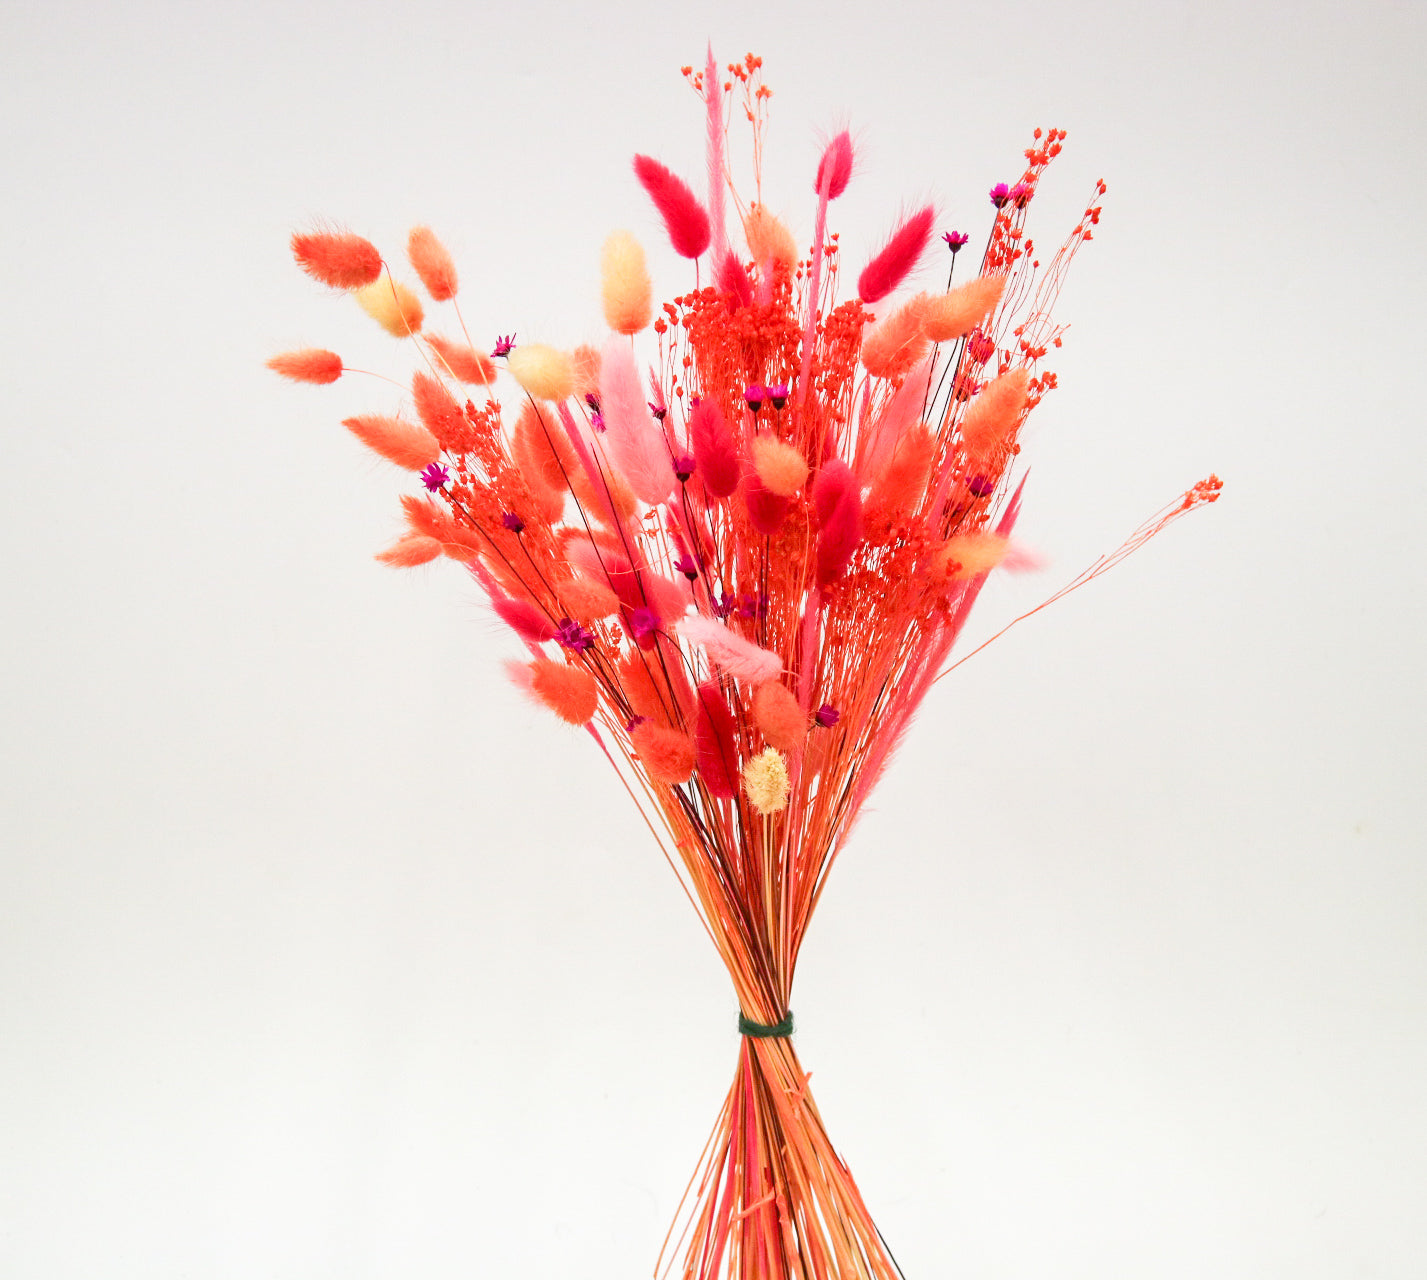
[[0, 0, 1427, 1280]]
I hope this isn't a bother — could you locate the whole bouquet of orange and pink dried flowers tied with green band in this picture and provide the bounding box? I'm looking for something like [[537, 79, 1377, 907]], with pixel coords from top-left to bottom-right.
[[271, 54, 1219, 1280]]
